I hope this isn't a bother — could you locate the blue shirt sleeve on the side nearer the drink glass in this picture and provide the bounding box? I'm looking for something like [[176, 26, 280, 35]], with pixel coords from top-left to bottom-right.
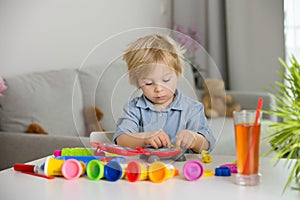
[[187, 103, 216, 152]]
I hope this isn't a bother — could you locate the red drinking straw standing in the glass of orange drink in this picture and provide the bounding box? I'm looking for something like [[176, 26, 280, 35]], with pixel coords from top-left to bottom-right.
[[243, 98, 264, 174]]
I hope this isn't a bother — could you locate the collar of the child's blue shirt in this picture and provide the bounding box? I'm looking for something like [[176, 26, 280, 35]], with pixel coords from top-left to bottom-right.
[[136, 89, 182, 111]]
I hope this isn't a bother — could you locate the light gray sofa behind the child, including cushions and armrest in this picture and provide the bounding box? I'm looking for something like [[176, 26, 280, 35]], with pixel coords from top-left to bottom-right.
[[0, 63, 270, 170]]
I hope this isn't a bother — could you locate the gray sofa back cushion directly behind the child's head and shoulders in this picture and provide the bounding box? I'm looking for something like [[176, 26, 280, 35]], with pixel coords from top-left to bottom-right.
[[79, 62, 197, 131]]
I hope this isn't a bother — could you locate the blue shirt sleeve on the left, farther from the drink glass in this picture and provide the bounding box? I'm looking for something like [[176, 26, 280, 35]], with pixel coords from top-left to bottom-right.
[[113, 101, 141, 143]]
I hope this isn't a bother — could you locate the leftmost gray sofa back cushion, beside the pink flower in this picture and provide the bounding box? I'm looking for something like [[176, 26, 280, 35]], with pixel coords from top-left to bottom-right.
[[0, 69, 85, 136]]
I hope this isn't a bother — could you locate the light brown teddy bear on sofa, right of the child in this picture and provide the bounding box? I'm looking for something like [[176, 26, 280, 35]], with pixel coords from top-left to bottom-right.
[[201, 79, 241, 118]]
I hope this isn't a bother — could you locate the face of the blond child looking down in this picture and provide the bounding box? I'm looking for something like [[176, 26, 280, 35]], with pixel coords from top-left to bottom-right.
[[138, 64, 178, 110]]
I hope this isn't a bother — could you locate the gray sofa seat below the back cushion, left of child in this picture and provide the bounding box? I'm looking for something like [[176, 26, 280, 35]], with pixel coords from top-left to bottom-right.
[[0, 132, 90, 170]]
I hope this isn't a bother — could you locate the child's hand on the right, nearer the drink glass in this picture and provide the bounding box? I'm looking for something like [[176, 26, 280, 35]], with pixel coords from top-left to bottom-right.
[[175, 130, 197, 148]]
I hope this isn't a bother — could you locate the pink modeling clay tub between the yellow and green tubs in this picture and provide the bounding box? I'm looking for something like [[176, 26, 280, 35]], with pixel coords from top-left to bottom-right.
[[61, 159, 86, 180]]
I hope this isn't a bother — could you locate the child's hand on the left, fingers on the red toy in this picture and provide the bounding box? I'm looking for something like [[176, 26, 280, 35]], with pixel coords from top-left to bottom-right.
[[146, 130, 171, 149]]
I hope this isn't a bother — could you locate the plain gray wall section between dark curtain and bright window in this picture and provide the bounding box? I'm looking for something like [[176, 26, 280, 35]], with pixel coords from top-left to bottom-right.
[[226, 0, 285, 91]]
